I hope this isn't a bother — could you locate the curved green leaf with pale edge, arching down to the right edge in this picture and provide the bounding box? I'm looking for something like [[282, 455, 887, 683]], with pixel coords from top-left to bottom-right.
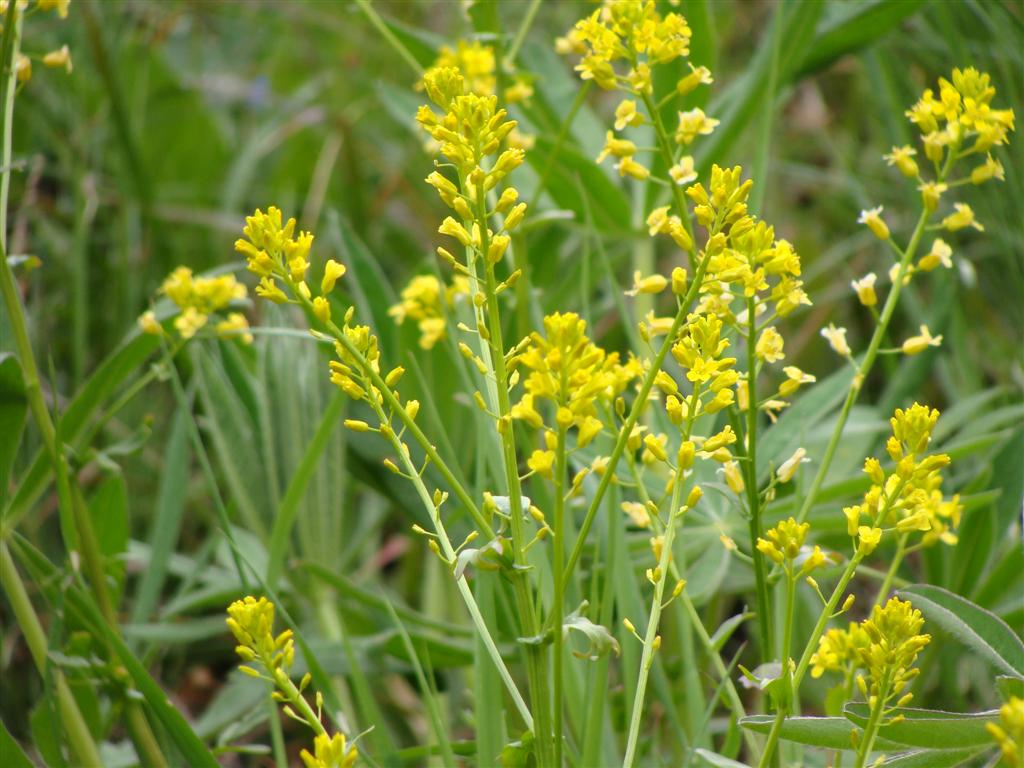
[[898, 584, 1024, 675]]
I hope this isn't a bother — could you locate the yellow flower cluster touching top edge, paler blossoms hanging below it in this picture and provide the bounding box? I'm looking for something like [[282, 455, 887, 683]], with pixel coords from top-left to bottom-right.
[[556, 0, 719, 184]]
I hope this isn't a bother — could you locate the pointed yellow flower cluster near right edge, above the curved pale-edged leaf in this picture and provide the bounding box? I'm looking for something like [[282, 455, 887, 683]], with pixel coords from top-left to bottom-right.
[[843, 402, 963, 554]]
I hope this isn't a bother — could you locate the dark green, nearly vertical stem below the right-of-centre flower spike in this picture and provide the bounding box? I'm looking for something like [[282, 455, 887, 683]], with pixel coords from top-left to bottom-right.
[[746, 296, 770, 660]]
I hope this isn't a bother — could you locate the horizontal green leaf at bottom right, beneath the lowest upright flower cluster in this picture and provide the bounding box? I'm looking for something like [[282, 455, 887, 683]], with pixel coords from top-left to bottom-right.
[[843, 701, 998, 750]]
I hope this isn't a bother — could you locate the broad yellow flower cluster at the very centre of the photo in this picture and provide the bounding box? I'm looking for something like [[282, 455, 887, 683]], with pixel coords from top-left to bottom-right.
[[510, 312, 618, 472]]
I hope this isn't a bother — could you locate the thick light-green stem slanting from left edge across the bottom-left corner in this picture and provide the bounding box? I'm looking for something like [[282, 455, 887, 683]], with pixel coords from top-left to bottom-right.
[[0, 542, 102, 766]]
